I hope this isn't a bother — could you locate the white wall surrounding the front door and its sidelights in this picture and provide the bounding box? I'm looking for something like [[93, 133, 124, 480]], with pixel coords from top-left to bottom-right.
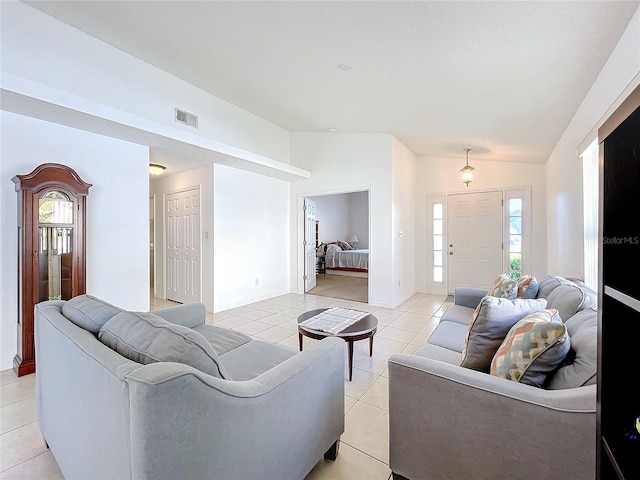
[[415, 158, 544, 293]]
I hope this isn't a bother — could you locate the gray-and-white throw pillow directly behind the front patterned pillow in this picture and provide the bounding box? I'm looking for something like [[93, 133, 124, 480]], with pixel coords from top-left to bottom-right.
[[460, 296, 547, 372]]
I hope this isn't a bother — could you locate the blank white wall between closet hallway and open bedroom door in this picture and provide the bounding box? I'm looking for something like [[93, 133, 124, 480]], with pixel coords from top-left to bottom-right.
[[213, 165, 290, 312]]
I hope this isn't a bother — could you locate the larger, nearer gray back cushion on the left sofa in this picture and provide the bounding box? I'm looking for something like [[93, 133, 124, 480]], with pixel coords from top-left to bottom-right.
[[98, 312, 229, 378]]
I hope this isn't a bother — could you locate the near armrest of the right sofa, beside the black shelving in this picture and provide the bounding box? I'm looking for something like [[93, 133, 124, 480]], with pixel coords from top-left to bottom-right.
[[389, 354, 596, 479]]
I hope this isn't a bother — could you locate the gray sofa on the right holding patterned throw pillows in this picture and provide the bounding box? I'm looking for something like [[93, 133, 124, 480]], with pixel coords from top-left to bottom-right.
[[389, 275, 597, 480]]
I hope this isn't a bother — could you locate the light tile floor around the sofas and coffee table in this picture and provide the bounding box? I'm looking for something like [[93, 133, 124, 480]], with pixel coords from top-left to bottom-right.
[[0, 294, 450, 480]]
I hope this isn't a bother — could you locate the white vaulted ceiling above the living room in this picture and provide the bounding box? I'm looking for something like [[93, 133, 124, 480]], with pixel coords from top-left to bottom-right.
[[20, 1, 640, 163]]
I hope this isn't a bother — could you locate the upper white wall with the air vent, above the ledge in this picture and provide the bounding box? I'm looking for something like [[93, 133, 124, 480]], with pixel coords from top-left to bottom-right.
[[0, 1, 289, 163]]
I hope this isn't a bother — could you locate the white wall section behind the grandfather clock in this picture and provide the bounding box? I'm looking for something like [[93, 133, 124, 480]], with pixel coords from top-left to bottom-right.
[[0, 111, 149, 370]]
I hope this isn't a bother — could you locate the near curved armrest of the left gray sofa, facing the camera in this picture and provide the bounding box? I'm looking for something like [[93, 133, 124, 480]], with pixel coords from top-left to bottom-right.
[[127, 338, 345, 480]]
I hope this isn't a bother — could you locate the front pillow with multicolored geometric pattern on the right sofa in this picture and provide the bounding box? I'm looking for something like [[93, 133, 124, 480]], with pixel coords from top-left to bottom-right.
[[490, 308, 571, 387]]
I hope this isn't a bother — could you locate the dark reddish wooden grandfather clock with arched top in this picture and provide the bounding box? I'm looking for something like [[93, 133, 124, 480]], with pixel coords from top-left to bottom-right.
[[11, 163, 91, 376]]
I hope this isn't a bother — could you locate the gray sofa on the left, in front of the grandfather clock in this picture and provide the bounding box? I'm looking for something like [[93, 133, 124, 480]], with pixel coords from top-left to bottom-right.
[[35, 295, 345, 480]]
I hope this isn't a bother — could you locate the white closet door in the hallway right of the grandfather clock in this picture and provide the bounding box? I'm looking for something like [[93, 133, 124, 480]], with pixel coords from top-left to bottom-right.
[[165, 188, 201, 303]]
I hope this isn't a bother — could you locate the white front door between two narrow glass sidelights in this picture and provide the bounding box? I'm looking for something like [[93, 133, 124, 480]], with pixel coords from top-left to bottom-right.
[[447, 191, 504, 294]]
